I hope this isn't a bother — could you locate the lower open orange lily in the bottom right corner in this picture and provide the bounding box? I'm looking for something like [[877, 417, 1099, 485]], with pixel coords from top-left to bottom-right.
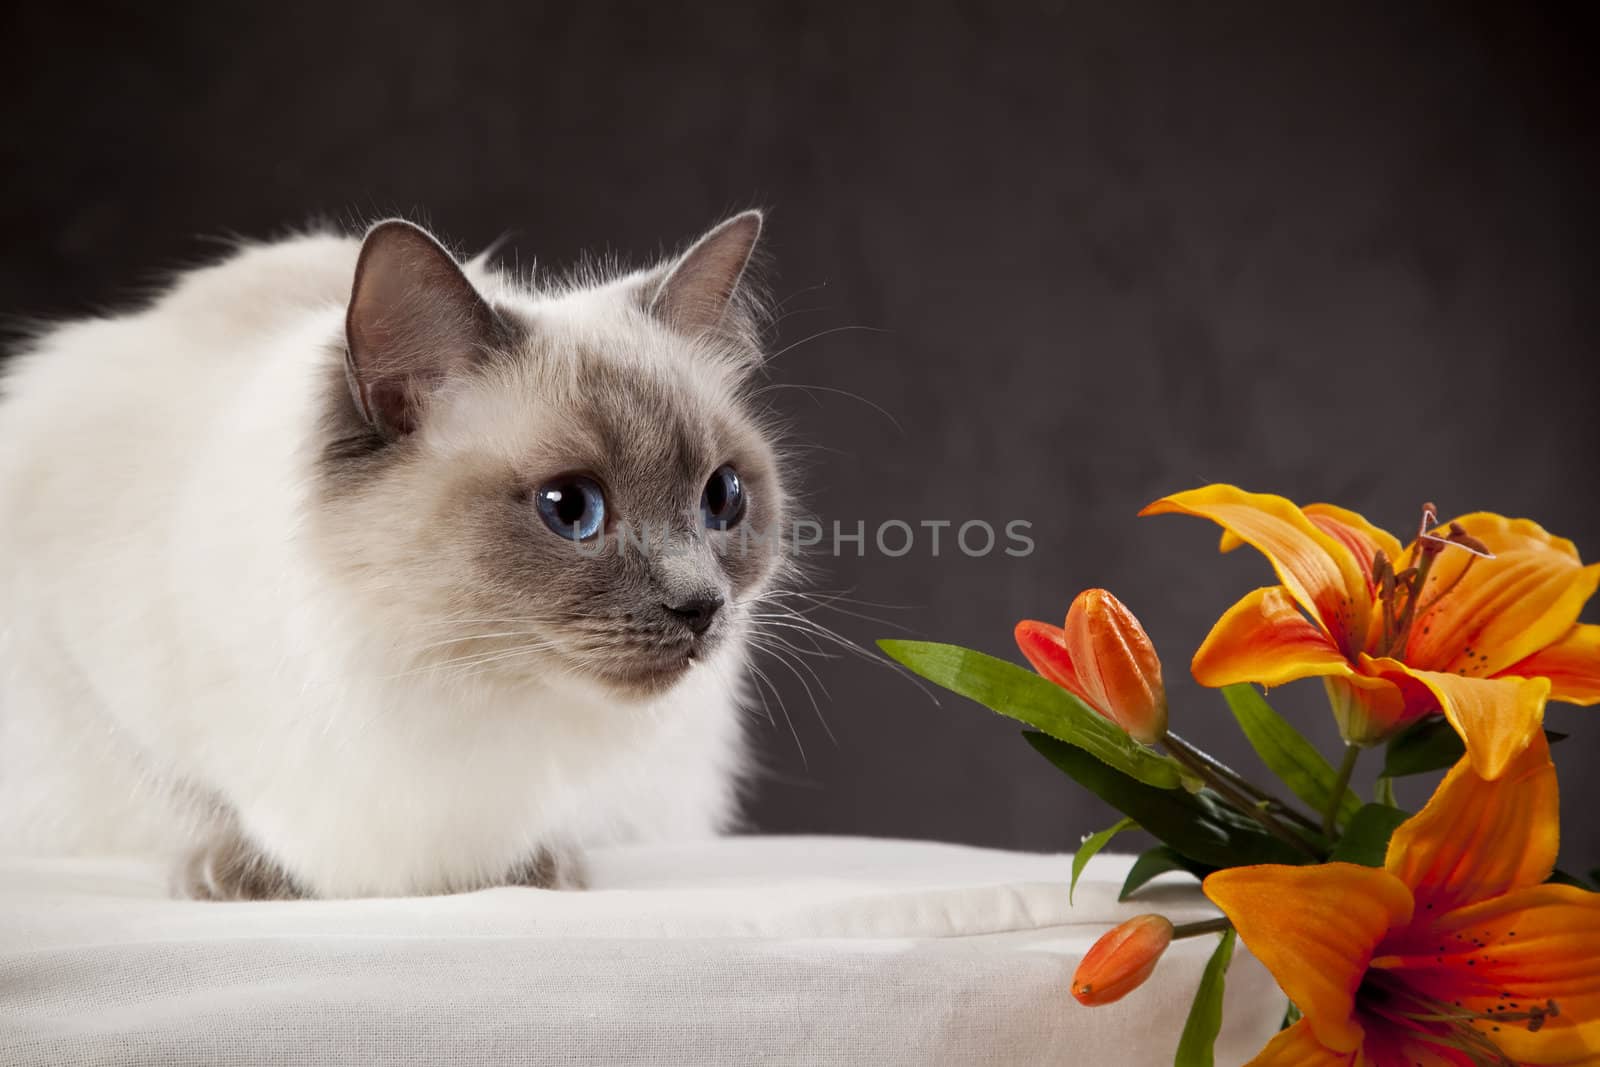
[[1205, 733, 1600, 1067]]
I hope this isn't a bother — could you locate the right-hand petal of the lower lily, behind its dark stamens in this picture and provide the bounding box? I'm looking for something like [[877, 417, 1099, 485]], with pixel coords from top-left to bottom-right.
[[1395, 885, 1600, 1064]]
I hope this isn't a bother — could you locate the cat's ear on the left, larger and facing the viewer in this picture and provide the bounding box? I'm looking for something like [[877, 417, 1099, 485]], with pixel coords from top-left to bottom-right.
[[344, 219, 502, 440]]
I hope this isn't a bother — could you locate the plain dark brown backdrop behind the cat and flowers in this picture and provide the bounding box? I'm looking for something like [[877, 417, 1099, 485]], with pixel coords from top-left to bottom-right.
[[0, 0, 1600, 869]]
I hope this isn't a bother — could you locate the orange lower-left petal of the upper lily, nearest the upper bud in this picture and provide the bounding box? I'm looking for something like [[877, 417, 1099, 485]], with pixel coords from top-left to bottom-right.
[[1190, 585, 1354, 688]]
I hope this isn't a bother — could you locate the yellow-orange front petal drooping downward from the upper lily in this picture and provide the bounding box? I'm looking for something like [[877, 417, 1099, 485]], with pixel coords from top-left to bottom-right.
[[1362, 654, 1550, 781]]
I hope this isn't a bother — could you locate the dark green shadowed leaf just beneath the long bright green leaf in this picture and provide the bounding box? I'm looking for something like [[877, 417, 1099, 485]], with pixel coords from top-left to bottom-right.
[[1022, 729, 1310, 867]]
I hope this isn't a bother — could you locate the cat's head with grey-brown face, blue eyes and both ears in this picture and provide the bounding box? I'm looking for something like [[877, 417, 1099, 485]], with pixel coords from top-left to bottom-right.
[[315, 211, 787, 697]]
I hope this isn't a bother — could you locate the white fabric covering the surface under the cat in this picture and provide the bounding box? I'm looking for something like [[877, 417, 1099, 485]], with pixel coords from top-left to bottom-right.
[[0, 837, 1285, 1067]]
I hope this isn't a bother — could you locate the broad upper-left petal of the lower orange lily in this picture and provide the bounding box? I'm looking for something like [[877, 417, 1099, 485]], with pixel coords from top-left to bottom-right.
[[1203, 864, 1411, 1053]]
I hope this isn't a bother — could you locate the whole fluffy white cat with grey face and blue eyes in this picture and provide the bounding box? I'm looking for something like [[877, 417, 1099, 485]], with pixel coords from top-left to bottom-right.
[[0, 211, 787, 897]]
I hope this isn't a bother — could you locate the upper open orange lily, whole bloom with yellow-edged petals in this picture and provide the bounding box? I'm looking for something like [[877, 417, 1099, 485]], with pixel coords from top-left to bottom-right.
[[1141, 485, 1600, 779]]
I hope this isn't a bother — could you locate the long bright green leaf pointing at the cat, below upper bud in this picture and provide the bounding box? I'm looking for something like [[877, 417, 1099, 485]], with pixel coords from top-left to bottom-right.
[[878, 640, 1182, 789]]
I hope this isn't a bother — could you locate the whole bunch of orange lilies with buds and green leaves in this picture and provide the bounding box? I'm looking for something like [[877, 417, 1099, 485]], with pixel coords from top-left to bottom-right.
[[880, 485, 1600, 1067]]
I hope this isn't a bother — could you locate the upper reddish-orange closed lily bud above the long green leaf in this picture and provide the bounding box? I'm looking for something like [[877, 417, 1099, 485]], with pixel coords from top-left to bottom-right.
[[1016, 589, 1166, 744]]
